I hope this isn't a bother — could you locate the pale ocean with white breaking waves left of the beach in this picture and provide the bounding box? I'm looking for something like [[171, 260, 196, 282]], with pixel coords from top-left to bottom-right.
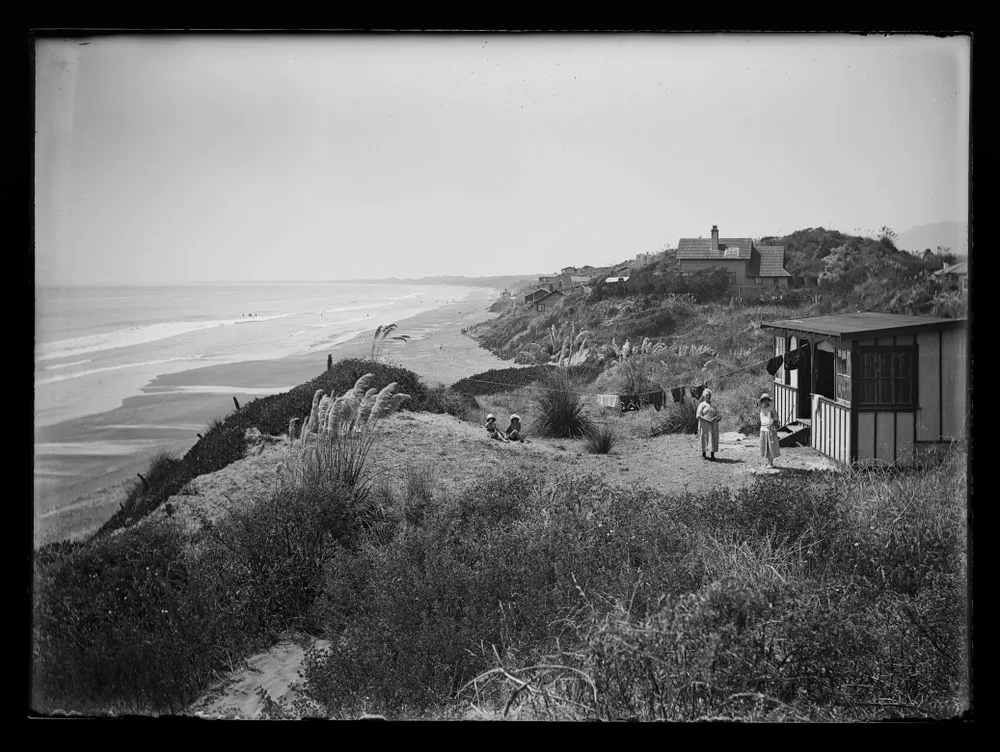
[[34, 282, 473, 540]]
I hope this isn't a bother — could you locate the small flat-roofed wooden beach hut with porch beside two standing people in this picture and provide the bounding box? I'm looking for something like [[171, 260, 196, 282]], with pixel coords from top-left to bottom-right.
[[762, 313, 969, 465]]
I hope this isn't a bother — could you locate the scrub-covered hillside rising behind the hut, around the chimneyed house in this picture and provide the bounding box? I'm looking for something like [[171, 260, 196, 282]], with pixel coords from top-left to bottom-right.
[[478, 228, 967, 378]]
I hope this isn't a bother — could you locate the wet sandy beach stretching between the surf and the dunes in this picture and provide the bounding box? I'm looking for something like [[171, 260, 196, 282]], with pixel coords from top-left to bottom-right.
[[34, 289, 510, 545]]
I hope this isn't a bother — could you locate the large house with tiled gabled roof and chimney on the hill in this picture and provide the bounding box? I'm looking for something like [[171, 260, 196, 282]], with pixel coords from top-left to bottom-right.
[[677, 225, 792, 287]]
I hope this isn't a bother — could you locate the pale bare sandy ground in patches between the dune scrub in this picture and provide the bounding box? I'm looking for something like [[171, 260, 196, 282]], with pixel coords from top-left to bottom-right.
[[182, 412, 836, 719]]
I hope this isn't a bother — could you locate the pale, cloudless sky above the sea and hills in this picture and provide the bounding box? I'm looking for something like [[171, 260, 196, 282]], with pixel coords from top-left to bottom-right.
[[34, 34, 970, 285]]
